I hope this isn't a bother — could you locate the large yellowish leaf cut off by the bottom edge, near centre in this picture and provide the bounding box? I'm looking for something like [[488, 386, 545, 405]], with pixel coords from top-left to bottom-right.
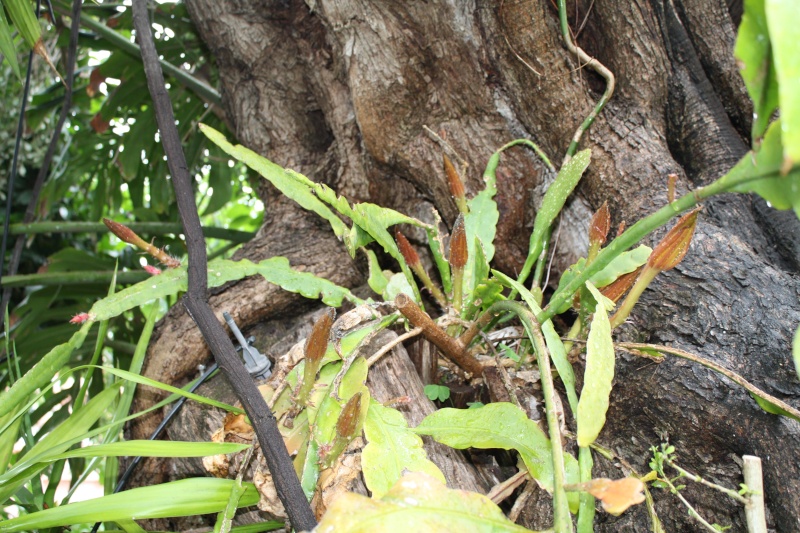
[[317, 470, 530, 533]]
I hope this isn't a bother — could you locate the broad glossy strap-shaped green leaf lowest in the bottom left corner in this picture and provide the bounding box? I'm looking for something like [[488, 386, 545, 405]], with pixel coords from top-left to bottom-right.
[[0, 478, 259, 533]]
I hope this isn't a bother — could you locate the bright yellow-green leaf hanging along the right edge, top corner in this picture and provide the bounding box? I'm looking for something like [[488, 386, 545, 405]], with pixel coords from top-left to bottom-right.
[[764, 0, 800, 164]]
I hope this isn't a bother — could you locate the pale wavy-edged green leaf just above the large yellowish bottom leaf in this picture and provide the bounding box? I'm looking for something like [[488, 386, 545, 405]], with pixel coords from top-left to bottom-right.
[[361, 401, 445, 498]]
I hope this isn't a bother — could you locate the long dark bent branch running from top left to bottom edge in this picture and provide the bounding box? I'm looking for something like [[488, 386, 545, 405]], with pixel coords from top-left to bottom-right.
[[133, 0, 317, 531]]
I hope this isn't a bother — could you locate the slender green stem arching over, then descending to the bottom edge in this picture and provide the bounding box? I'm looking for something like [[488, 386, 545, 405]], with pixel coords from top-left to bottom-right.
[[487, 301, 572, 533]]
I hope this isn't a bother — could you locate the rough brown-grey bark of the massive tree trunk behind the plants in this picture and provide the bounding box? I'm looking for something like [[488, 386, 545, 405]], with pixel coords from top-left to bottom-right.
[[126, 0, 800, 532]]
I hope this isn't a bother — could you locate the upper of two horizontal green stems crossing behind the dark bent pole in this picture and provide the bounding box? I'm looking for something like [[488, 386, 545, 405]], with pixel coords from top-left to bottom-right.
[[9, 221, 255, 243]]
